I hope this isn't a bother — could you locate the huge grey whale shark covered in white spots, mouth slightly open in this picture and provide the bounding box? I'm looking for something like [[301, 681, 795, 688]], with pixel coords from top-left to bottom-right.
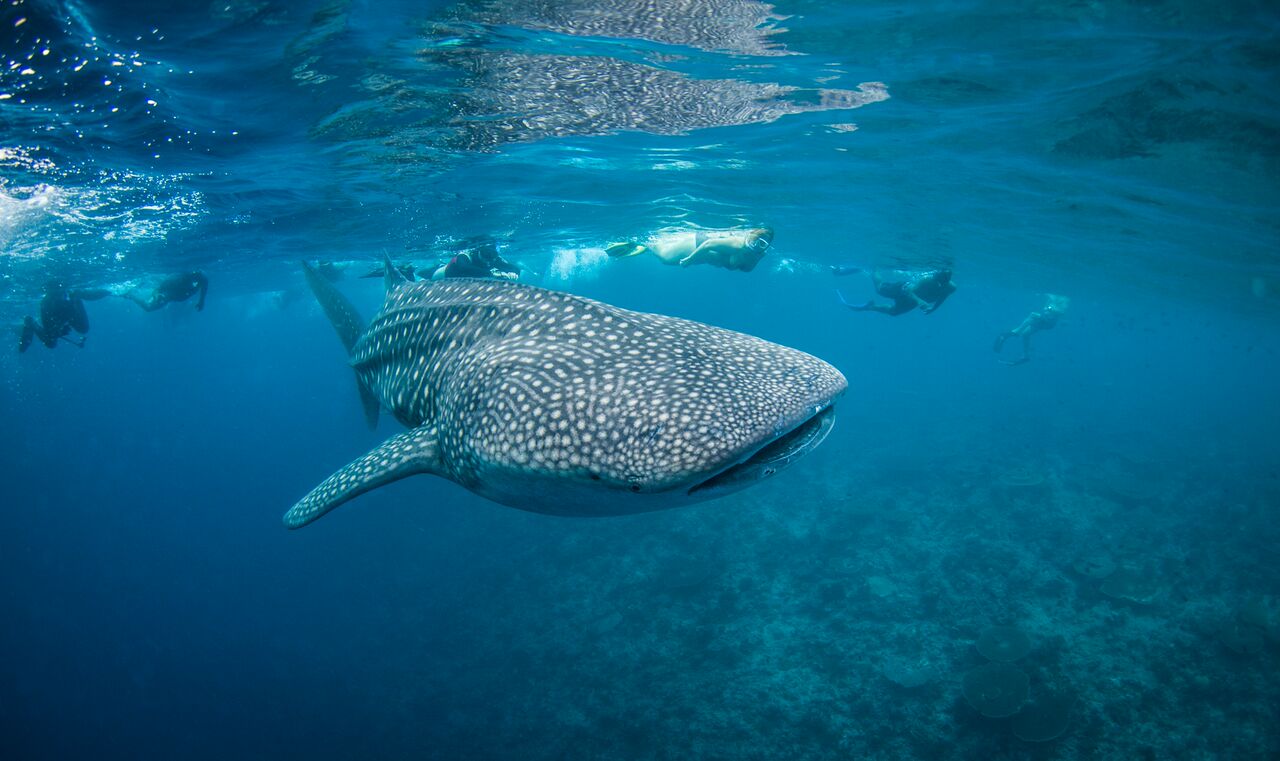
[[284, 265, 847, 528]]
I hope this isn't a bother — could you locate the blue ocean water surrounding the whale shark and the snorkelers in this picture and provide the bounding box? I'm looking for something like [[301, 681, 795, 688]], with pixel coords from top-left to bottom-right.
[[0, 0, 1280, 758]]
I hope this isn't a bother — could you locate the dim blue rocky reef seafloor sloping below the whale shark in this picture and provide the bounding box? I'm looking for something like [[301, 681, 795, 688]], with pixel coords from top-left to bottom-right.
[[345, 437, 1280, 758]]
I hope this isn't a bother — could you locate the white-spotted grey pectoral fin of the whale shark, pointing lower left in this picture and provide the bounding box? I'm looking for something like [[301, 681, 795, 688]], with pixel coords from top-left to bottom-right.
[[284, 427, 440, 528]]
